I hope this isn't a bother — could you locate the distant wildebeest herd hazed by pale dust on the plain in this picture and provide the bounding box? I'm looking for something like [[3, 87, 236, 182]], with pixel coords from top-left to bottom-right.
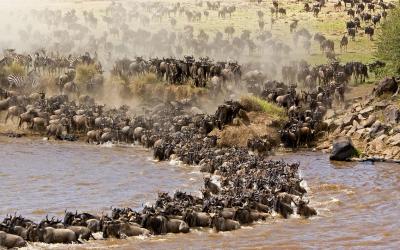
[[0, 0, 394, 73]]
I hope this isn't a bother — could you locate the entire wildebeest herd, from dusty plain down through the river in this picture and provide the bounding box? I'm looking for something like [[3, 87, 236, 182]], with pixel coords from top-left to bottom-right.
[[0, 0, 394, 248]]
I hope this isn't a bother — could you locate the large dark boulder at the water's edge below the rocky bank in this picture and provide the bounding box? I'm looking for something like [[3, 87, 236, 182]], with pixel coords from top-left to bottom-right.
[[329, 137, 358, 161]]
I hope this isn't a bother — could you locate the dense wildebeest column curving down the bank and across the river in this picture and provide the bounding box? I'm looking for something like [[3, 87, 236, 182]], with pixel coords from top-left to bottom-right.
[[0, 96, 316, 247]]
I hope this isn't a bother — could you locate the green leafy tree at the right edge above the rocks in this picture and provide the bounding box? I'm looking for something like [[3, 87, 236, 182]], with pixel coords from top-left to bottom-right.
[[376, 8, 400, 74]]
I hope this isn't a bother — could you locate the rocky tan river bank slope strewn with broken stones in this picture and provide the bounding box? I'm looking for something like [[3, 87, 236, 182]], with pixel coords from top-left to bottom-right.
[[317, 79, 400, 163]]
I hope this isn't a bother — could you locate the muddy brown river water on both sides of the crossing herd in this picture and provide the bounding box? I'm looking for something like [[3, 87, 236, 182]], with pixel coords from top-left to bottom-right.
[[0, 137, 400, 249]]
